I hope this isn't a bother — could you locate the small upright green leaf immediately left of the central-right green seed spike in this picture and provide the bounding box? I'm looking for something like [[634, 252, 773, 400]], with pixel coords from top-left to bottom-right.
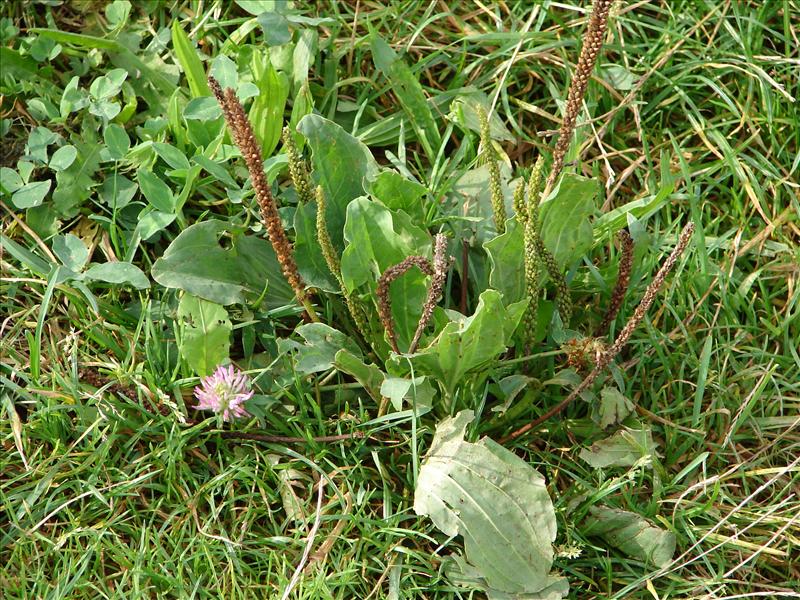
[[483, 219, 526, 304]]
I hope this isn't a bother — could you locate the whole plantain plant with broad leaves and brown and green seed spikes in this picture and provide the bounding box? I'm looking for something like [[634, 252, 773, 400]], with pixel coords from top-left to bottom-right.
[[153, 0, 692, 598]]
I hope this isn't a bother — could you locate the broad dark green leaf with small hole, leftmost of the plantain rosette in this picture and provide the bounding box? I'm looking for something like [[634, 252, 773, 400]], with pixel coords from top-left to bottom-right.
[[151, 220, 294, 308]]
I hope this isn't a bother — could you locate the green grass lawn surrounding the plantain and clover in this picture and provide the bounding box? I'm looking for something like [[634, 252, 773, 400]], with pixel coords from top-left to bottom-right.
[[0, 0, 800, 599]]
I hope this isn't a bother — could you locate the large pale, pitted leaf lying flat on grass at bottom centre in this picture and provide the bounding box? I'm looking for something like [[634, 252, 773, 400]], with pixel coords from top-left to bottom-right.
[[414, 410, 566, 597]]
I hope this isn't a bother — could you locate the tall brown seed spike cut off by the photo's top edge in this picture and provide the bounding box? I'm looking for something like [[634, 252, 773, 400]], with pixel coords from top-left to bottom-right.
[[544, 0, 614, 195]]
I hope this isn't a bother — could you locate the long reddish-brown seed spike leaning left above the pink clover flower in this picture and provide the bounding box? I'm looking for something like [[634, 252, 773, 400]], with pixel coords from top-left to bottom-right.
[[208, 76, 317, 320]]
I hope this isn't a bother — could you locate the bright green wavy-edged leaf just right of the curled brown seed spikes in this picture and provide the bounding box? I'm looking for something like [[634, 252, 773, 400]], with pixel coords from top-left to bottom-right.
[[395, 290, 527, 396]]
